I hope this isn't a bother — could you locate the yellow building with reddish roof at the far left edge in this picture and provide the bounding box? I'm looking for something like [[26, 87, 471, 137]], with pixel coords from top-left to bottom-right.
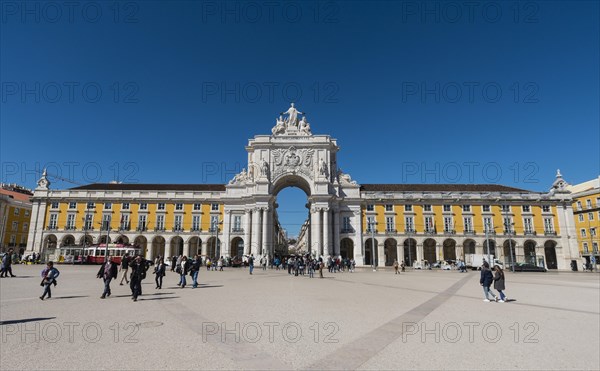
[[0, 183, 33, 254]]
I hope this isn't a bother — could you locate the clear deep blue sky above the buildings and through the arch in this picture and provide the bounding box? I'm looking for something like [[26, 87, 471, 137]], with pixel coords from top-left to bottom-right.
[[0, 1, 600, 237]]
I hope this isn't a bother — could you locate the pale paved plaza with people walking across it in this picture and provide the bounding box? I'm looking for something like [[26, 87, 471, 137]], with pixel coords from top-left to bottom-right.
[[0, 265, 600, 370]]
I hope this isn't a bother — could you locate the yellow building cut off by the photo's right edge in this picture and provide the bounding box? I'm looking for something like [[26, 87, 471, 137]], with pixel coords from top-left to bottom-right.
[[567, 177, 600, 263]]
